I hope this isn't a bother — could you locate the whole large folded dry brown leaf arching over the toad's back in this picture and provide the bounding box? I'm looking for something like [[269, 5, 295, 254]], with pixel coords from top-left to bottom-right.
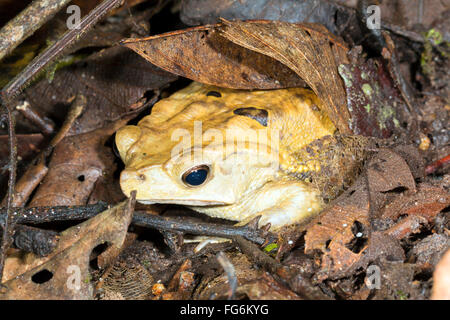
[[122, 20, 350, 134]]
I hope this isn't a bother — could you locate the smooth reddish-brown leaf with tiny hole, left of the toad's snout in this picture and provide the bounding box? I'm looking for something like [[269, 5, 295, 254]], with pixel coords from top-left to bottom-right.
[[29, 119, 128, 207]]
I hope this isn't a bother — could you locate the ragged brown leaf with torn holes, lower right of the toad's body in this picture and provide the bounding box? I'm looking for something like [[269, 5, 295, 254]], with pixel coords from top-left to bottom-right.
[[305, 148, 416, 281]]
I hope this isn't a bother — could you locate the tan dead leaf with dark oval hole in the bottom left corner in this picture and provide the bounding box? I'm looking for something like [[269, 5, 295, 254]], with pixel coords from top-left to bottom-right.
[[0, 198, 134, 300]]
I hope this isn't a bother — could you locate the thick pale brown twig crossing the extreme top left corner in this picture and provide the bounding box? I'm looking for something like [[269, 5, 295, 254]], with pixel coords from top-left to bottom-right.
[[0, 0, 70, 60]]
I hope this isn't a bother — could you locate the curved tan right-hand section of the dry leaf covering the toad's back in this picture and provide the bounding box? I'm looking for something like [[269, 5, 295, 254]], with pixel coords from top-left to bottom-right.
[[218, 20, 350, 134]]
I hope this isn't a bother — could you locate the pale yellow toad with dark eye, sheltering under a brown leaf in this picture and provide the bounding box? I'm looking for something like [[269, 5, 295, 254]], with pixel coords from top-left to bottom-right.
[[116, 82, 342, 230]]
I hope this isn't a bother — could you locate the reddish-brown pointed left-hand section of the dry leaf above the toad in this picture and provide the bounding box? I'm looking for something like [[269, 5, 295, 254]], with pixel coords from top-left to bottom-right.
[[122, 24, 305, 89]]
